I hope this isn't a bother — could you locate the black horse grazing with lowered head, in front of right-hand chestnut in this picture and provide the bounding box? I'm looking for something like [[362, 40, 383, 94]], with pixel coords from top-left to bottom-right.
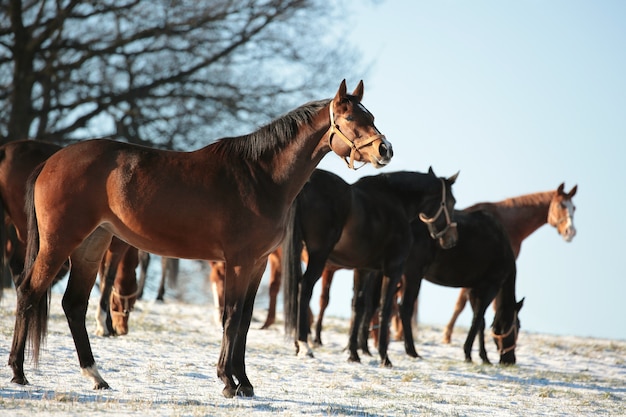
[[349, 211, 524, 364]]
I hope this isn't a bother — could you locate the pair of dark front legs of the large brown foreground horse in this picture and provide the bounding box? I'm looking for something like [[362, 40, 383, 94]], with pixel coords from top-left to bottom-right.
[[217, 262, 265, 398]]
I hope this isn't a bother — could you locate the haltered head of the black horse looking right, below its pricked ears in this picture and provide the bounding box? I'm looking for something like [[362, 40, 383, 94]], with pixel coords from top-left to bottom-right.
[[419, 167, 459, 249]]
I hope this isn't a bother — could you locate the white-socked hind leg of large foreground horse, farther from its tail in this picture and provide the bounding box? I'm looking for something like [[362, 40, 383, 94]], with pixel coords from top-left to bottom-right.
[[63, 229, 111, 389]]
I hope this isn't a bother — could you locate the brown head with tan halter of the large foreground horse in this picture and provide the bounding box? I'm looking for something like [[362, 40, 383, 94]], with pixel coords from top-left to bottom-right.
[[328, 80, 393, 169]]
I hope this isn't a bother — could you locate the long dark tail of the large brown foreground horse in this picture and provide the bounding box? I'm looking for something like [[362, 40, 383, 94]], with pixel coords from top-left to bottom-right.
[[15, 164, 50, 364]]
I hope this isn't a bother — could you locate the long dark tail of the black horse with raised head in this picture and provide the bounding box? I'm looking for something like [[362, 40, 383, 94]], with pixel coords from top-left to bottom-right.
[[281, 199, 303, 335]]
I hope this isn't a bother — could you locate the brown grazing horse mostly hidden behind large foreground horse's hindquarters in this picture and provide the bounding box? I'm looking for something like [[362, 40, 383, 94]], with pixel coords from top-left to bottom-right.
[[0, 140, 137, 335]]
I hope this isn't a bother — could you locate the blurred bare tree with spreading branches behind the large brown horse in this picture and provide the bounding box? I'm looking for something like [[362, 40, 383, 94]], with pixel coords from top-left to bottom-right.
[[0, 0, 363, 149]]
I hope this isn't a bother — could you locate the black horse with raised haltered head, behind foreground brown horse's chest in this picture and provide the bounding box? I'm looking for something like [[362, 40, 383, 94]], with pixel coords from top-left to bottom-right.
[[282, 169, 458, 366]]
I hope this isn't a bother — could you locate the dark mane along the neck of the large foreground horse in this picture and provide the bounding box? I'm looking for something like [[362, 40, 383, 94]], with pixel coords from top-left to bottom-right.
[[209, 99, 330, 161]]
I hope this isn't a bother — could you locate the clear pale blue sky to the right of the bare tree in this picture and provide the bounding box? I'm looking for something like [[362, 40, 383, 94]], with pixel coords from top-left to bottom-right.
[[313, 0, 626, 340]]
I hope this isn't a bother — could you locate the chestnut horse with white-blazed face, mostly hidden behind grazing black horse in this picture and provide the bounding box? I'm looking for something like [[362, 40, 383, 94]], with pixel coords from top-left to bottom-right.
[[443, 183, 578, 343]]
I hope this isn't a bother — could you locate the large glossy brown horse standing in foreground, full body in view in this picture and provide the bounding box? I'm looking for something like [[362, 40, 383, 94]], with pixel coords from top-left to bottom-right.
[[9, 80, 393, 397]]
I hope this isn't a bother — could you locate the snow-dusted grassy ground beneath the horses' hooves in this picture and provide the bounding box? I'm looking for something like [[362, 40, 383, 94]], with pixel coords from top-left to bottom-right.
[[0, 290, 626, 416]]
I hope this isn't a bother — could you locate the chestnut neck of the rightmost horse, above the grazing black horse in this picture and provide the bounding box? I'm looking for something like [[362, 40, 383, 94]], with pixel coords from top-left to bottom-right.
[[468, 191, 554, 258]]
